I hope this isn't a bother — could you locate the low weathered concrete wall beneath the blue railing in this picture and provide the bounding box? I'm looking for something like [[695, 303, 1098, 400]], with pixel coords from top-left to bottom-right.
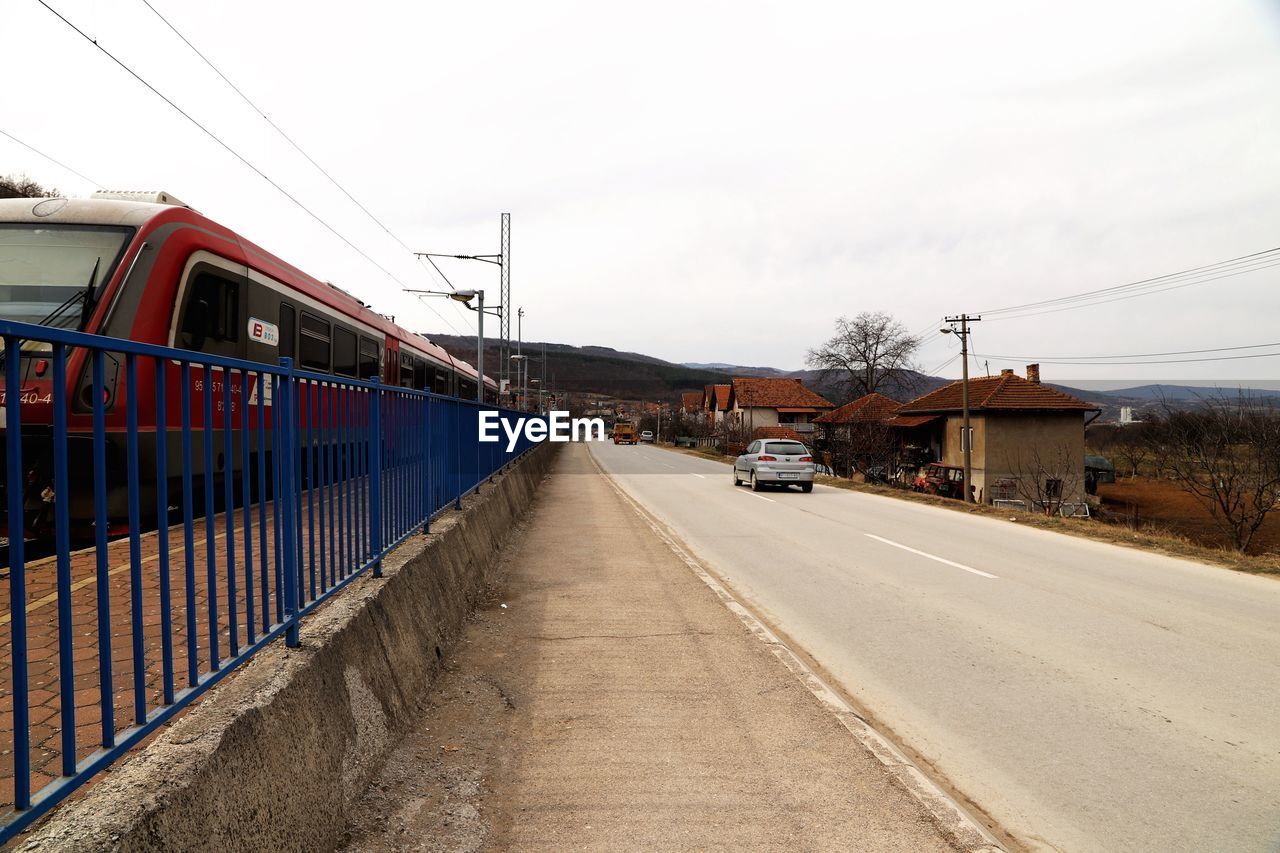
[[18, 444, 559, 850]]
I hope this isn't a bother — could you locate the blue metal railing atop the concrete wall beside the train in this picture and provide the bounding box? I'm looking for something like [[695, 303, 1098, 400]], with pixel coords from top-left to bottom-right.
[[0, 320, 531, 843]]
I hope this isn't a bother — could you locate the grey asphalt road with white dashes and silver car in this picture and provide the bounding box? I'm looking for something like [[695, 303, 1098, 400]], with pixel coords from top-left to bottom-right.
[[591, 443, 1280, 852]]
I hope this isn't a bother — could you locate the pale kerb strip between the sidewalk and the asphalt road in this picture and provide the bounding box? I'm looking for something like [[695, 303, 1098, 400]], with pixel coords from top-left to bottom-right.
[[588, 448, 1007, 853]]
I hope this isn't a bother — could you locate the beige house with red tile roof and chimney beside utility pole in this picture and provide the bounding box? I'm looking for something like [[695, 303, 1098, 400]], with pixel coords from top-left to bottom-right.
[[888, 364, 1101, 508]]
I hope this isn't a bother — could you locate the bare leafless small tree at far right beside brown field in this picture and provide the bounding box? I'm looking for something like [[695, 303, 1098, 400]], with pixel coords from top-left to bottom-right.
[[1149, 394, 1280, 553]]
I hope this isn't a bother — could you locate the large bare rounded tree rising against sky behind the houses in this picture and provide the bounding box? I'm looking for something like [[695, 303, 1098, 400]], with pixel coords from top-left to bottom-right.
[[805, 311, 920, 400]]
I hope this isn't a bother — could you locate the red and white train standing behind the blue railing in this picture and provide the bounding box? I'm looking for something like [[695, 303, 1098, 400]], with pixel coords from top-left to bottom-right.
[[0, 192, 498, 535]]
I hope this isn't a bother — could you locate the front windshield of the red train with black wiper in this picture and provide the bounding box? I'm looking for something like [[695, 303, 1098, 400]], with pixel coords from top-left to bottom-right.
[[0, 223, 133, 329]]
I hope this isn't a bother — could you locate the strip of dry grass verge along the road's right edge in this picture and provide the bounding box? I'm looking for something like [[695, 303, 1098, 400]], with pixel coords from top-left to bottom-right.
[[664, 446, 1280, 578]]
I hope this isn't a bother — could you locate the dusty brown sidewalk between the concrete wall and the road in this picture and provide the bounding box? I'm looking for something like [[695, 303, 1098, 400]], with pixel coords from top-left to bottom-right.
[[348, 444, 955, 850]]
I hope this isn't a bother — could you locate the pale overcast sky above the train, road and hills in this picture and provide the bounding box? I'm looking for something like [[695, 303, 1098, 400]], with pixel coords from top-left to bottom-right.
[[0, 0, 1280, 380]]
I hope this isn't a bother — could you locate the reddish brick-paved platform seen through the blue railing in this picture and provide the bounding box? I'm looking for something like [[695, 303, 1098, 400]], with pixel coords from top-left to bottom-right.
[[0, 487, 367, 808]]
